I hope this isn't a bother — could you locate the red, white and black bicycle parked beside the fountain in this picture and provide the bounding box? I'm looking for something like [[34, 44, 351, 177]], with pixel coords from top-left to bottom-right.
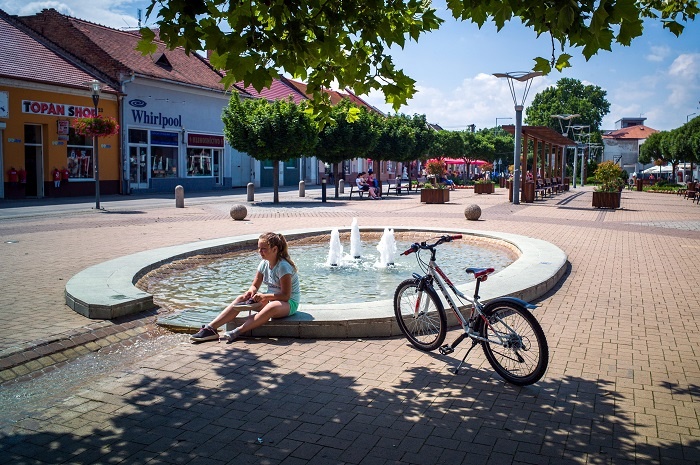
[[394, 235, 549, 386]]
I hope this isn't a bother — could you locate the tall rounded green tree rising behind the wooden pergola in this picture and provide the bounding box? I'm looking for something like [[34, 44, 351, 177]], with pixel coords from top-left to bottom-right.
[[525, 78, 610, 133]]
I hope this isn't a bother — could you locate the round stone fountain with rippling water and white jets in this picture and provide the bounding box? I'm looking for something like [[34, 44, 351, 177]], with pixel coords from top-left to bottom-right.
[[66, 226, 567, 338]]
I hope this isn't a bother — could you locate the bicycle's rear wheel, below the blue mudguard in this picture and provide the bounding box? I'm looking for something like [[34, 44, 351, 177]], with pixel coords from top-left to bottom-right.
[[481, 302, 549, 386]]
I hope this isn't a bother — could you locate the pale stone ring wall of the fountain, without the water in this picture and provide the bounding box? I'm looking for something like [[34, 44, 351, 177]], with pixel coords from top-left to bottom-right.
[[66, 227, 567, 338]]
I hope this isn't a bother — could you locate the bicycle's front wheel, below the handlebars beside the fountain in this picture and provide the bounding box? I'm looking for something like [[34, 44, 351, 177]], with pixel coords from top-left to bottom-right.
[[394, 279, 447, 351]]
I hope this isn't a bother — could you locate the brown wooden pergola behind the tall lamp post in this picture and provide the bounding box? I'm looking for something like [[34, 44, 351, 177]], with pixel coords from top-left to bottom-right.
[[503, 124, 576, 194]]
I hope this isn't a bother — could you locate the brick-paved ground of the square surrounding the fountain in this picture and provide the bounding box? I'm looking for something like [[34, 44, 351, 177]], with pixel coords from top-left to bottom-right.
[[0, 187, 700, 464]]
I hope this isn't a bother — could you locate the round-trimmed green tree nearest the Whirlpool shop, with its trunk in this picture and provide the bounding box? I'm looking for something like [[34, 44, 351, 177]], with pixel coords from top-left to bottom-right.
[[221, 93, 318, 203]]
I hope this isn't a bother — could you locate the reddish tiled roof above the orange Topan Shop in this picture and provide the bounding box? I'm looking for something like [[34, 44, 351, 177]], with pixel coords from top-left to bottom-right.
[[0, 10, 115, 92]]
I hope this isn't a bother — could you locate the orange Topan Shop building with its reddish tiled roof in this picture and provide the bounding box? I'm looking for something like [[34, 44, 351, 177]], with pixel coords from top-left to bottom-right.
[[0, 11, 120, 198]]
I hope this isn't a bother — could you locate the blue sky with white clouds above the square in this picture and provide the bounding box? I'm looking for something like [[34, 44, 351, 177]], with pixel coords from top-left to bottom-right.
[[5, 0, 700, 130]]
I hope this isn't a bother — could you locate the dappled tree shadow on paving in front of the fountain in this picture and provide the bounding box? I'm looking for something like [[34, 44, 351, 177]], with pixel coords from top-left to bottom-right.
[[0, 339, 700, 464]]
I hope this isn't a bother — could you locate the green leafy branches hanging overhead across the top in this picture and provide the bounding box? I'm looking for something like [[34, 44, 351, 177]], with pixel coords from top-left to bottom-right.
[[138, 0, 700, 113]]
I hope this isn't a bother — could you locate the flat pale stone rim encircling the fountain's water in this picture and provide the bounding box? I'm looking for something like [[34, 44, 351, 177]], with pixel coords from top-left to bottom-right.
[[65, 226, 567, 328]]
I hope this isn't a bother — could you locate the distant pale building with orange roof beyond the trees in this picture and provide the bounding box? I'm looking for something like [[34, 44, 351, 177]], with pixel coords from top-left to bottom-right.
[[603, 117, 659, 176]]
